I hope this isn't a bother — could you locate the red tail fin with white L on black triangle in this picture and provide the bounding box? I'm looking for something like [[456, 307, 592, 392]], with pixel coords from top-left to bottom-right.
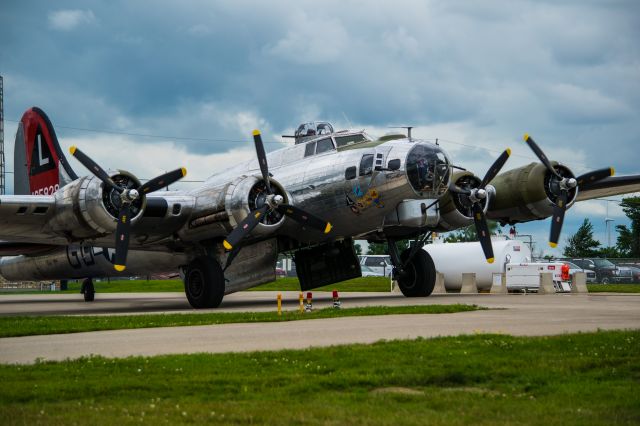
[[13, 107, 78, 195]]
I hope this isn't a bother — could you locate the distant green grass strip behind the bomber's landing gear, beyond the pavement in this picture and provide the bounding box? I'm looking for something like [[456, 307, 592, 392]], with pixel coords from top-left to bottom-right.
[[0, 277, 391, 295]]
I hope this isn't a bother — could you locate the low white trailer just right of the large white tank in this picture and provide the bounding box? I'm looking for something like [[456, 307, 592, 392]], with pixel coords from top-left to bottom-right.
[[507, 262, 571, 293]]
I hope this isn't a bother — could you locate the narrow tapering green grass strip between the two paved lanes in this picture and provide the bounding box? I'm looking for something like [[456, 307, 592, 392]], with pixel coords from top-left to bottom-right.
[[0, 303, 484, 337]]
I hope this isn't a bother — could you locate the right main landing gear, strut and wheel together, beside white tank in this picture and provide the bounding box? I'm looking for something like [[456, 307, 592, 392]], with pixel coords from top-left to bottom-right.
[[388, 236, 436, 297]]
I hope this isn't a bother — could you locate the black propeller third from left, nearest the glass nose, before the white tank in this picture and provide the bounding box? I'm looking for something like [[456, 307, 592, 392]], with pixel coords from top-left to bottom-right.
[[449, 148, 511, 263]]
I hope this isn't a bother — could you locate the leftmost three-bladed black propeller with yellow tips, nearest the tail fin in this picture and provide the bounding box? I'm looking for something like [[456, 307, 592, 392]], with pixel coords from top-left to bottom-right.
[[69, 146, 187, 272]]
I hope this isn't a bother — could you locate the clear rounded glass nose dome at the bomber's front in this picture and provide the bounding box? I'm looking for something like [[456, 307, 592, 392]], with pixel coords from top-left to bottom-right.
[[406, 144, 451, 198]]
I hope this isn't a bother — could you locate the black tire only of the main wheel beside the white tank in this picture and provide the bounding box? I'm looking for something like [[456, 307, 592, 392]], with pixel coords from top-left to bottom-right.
[[398, 249, 436, 297]]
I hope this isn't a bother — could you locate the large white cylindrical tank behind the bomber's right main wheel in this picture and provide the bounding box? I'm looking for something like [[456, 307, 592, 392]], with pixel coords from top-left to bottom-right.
[[424, 240, 531, 291]]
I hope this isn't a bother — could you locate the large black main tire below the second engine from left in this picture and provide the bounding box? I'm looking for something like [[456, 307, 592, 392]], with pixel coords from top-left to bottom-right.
[[184, 257, 224, 309]]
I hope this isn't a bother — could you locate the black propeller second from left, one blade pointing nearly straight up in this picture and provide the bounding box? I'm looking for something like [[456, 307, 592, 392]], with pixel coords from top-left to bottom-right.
[[222, 130, 331, 253]]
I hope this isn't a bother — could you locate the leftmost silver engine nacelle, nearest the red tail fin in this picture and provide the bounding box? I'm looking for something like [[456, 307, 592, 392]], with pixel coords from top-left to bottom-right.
[[48, 170, 146, 240]]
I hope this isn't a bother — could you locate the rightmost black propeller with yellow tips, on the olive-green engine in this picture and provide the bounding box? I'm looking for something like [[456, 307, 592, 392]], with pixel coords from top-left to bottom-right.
[[523, 134, 615, 248]]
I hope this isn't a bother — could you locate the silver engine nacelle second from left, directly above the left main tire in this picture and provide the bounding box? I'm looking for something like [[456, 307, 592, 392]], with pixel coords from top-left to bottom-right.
[[224, 176, 290, 235]]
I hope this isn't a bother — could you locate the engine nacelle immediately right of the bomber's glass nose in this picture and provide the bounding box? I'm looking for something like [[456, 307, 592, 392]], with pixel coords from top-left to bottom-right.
[[437, 171, 495, 232]]
